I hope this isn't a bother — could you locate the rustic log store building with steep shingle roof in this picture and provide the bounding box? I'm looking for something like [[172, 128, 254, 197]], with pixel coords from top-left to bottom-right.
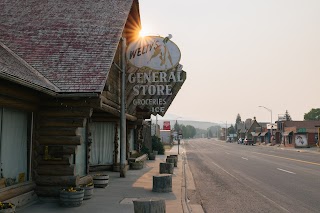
[[0, 0, 186, 201]]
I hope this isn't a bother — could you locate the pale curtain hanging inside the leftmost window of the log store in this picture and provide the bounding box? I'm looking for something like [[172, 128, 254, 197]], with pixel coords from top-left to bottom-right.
[[0, 108, 28, 182]]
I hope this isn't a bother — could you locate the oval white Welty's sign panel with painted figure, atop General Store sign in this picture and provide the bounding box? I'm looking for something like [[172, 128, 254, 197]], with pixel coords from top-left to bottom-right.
[[127, 36, 181, 71]]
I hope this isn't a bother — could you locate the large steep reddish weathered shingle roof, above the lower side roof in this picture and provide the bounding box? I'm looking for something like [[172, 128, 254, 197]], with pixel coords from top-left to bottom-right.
[[0, 0, 133, 92]]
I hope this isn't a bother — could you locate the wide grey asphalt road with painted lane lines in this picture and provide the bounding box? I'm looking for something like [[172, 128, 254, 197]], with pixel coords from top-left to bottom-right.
[[185, 139, 320, 213]]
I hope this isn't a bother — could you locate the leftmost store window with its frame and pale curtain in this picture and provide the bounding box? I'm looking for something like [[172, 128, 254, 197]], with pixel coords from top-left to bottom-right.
[[0, 107, 32, 188]]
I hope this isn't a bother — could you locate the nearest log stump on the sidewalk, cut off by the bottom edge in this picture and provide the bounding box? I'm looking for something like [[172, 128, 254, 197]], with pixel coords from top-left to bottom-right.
[[133, 198, 166, 213]]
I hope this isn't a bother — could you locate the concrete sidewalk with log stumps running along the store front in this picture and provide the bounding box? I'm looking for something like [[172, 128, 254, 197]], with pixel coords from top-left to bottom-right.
[[17, 145, 189, 213]]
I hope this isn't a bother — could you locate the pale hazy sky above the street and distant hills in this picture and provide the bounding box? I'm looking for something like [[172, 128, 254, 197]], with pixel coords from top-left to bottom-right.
[[139, 0, 320, 123]]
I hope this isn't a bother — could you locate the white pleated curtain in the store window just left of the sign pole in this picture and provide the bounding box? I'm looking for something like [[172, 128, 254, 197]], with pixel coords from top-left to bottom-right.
[[89, 122, 115, 165]]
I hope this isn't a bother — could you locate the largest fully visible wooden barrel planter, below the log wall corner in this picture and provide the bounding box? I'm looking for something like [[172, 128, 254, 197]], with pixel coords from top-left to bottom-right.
[[60, 188, 84, 207]]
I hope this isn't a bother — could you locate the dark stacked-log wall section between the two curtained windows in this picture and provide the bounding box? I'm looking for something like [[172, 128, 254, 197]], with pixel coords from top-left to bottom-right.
[[33, 99, 95, 196]]
